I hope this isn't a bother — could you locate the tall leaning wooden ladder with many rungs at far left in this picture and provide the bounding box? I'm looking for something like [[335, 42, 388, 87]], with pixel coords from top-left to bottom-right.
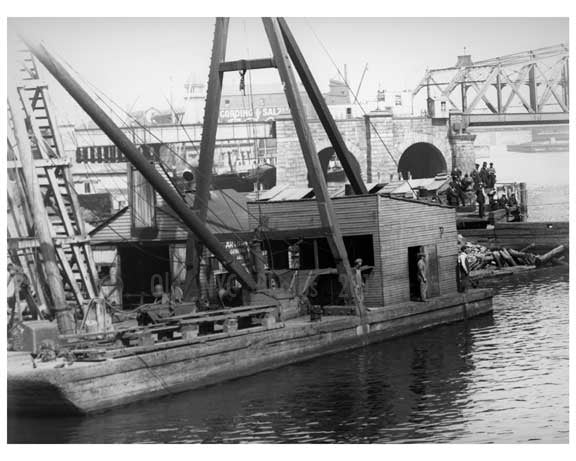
[[8, 46, 99, 310]]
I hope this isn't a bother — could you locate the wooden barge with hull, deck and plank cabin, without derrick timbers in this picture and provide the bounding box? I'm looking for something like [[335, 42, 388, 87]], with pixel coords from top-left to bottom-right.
[[8, 195, 492, 414]]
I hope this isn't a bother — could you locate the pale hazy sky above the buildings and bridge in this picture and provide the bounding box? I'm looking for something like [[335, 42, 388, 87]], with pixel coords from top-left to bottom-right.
[[8, 17, 568, 122]]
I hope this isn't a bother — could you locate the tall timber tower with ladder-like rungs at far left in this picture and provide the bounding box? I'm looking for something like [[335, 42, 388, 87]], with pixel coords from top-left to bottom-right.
[[7, 51, 99, 333]]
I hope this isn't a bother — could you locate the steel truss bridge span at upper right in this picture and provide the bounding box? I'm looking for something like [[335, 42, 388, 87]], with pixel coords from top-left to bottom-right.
[[412, 44, 570, 126]]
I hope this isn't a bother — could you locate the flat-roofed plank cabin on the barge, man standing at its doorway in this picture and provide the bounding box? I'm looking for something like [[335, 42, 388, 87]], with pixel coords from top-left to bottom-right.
[[248, 194, 458, 307]]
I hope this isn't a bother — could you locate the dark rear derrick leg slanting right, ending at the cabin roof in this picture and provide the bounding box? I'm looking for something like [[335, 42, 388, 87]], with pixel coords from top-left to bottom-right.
[[278, 18, 368, 195]]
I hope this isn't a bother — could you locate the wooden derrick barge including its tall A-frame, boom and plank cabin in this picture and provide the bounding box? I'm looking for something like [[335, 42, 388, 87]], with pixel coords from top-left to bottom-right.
[[8, 18, 492, 414]]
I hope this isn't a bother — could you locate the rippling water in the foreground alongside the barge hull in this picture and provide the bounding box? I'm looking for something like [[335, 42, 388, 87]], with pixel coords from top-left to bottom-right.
[[8, 269, 568, 443]]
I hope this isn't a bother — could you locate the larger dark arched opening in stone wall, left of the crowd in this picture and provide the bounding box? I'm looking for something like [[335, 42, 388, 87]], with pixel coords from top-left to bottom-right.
[[398, 142, 447, 179]]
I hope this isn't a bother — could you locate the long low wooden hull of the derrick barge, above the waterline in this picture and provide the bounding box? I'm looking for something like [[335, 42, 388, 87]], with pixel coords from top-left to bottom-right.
[[8, 289, 492, 415]]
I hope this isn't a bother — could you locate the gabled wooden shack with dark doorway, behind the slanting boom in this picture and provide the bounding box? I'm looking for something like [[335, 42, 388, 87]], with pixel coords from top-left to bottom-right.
[[90, 190, 248, 308]]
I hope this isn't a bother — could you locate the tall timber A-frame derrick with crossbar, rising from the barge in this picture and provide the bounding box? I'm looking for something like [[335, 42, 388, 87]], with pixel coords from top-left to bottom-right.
[[185, 18, 367, 317]]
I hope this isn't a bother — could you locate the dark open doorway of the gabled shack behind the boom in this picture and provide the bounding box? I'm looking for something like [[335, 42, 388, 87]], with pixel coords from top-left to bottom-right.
[[118, 244, 171, 309]]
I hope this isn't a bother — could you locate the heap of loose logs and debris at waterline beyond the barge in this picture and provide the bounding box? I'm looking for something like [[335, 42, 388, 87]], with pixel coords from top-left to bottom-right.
[[459, 237, 568, 275]]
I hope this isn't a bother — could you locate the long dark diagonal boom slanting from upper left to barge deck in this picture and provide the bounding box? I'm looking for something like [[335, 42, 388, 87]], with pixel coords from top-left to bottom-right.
[[22, 37, 256, 290]]
